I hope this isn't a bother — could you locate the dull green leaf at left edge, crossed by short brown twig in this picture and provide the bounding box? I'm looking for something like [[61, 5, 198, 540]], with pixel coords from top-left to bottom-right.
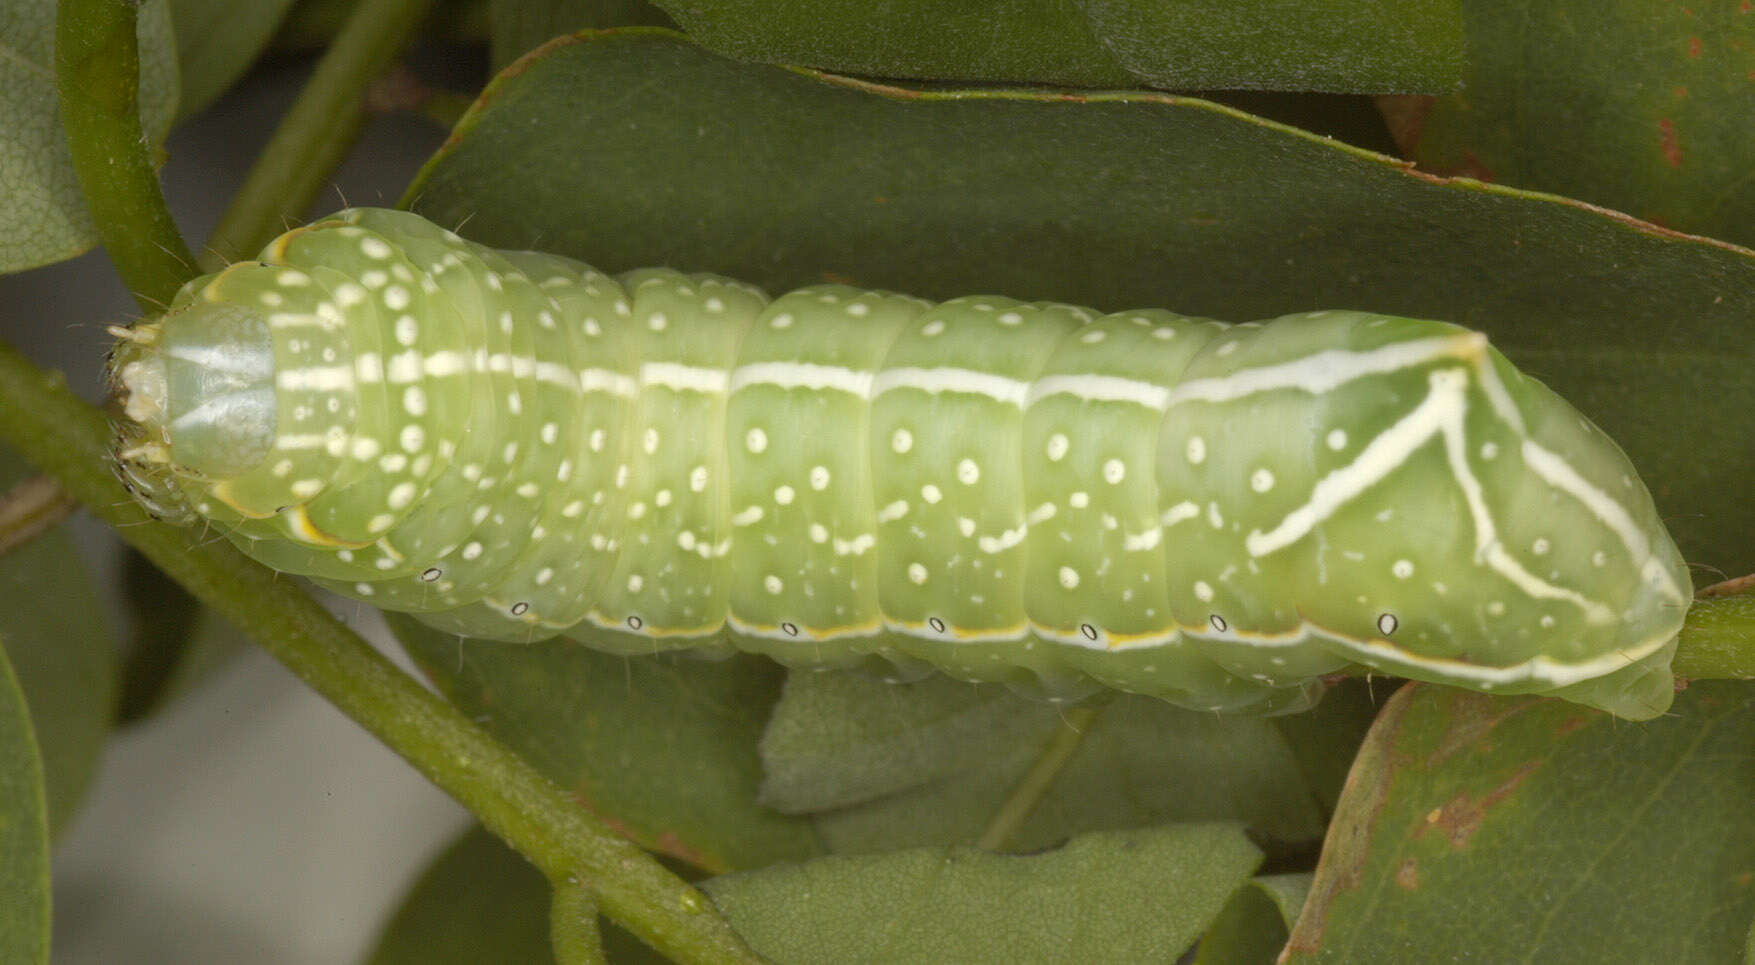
[[0, 449, 118, 838]]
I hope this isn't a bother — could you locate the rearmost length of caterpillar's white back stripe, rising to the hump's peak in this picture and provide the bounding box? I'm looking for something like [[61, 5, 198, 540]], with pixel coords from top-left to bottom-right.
[[1171, 332, 1486, 405]]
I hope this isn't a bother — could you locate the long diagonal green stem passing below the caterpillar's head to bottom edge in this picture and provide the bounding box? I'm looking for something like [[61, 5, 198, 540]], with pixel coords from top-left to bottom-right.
[[0, 344, 756, 961]]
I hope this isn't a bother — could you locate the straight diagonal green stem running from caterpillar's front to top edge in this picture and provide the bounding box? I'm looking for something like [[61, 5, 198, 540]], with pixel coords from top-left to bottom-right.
[[202, 0, 432, 268]]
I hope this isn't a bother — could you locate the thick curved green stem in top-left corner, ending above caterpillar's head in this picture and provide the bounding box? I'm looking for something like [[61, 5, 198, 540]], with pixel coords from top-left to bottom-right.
[[54, 0, 195, 312]]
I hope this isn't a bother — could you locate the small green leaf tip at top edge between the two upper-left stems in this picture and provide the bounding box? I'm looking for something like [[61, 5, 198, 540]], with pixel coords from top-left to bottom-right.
[[168, 0, 293, 118]]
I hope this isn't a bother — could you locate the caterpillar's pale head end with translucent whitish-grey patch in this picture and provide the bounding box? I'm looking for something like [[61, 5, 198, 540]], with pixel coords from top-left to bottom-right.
[[109, 300, 277, 523]]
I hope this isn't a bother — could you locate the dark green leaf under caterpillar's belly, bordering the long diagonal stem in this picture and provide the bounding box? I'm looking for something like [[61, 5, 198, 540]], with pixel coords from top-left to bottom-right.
[[390, 614, 821, 872]]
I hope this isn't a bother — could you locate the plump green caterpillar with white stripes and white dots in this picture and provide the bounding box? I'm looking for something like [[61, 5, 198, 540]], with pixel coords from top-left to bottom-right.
[[112, 209, 1690, 718]]
